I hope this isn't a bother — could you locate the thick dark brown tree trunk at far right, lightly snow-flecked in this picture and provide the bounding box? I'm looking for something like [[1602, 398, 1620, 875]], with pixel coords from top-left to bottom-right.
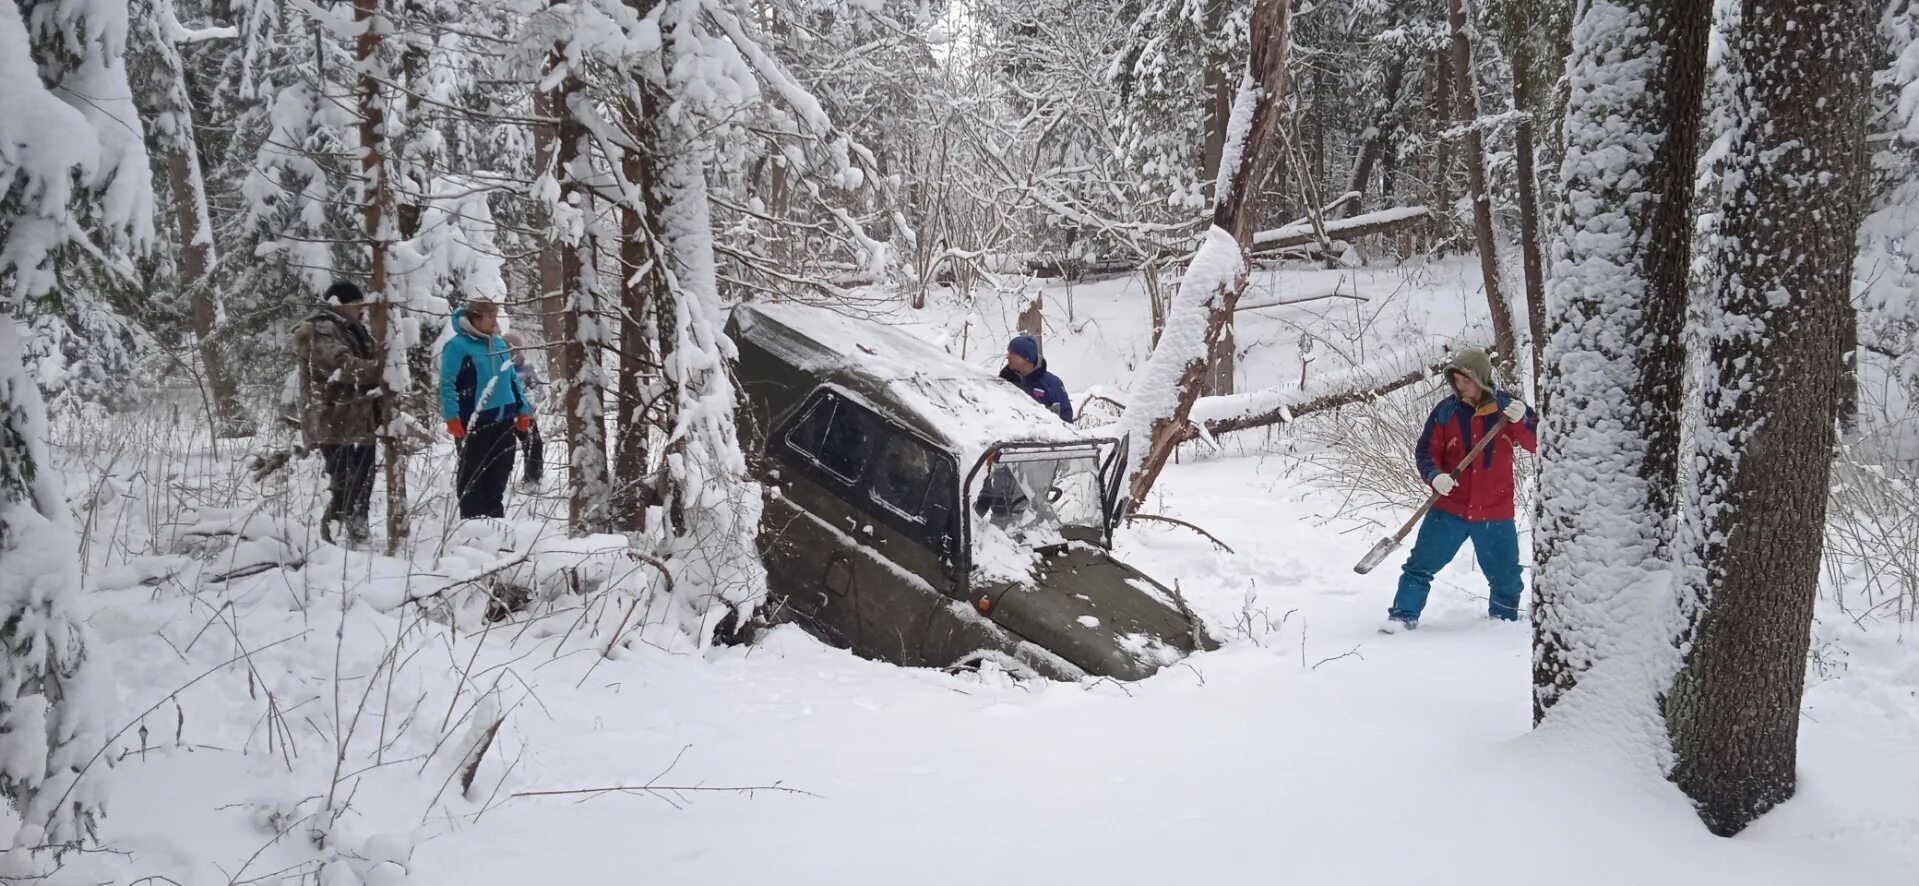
[[1666, 0, 1875, 836]]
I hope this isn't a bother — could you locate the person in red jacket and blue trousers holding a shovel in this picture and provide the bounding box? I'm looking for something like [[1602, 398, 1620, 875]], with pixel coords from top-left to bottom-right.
[[1380, 347, 1539, 633]]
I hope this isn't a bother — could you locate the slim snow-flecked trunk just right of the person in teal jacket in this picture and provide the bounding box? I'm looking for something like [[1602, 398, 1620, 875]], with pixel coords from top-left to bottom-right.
[[549, 75, 612, 535]]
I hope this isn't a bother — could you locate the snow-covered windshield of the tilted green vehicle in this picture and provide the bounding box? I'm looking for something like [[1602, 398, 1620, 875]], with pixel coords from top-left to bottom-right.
[[967, 445, 1105, 548]]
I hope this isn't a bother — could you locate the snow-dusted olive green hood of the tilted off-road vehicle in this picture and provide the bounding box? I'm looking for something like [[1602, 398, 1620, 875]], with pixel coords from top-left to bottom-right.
[[986, 545, 1219, 679]]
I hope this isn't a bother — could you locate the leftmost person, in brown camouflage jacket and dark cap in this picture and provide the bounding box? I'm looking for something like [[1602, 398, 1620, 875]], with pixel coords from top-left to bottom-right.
[[292, 282, 380, 543]]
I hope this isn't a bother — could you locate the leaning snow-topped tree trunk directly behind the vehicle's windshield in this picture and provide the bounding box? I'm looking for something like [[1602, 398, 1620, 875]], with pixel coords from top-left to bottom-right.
[[1119, 0, 1291, 502]]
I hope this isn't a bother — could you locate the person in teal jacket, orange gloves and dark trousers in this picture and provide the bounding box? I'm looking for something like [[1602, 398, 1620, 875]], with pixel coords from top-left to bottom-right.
[[439, 301, 533, 520]]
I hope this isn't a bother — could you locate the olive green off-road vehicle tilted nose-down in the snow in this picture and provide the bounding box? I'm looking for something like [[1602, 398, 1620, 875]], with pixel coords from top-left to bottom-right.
[[727, 305, 1217, 679]]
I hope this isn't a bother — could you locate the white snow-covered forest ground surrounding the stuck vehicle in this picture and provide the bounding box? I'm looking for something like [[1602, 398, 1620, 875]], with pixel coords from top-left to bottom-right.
[[26, 263, 1919, 886]]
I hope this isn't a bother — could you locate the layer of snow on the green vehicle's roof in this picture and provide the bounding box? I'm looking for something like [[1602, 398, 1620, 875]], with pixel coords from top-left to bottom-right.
[[733, 303, 1092, 460]]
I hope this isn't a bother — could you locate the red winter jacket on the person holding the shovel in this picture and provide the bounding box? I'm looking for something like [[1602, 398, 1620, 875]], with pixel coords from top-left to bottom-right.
[[1412, 393, 1539, 522]]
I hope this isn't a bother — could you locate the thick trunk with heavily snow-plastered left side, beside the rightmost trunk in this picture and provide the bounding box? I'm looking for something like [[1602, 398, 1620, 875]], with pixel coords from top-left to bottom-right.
[[1533, 0, 1712, 729]]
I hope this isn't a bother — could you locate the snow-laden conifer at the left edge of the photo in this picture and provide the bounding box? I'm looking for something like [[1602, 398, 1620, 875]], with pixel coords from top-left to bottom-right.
[[0, 0, 152, 848]]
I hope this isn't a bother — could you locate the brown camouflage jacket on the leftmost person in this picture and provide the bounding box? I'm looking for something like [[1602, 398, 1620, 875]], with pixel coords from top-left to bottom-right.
[[292, 307, 380, 447]]
